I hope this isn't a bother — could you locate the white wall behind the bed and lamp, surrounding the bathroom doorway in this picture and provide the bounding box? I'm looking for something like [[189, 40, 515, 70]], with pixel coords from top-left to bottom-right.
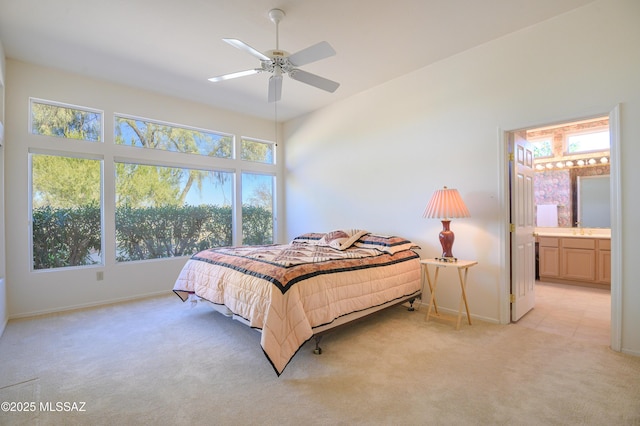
[[285, 0, 640, 355]]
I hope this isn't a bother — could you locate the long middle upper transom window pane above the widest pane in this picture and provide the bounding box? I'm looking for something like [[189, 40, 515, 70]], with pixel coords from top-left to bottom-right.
[[115, 116, 233, 158]]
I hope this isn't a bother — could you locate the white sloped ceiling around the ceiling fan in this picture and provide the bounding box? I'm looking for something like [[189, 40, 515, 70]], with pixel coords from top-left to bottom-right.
[[0, 0, 593, 121]]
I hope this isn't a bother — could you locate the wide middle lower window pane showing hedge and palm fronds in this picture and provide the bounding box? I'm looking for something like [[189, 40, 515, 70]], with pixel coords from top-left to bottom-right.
[[116, 162, 233, 262]]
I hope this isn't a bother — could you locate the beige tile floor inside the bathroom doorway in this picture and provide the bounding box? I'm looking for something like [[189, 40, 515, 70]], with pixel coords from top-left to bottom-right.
[[516, 281, 611, 346]]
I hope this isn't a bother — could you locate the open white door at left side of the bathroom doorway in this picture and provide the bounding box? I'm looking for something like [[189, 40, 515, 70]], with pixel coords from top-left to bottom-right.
[[509, 132, 536, 321]]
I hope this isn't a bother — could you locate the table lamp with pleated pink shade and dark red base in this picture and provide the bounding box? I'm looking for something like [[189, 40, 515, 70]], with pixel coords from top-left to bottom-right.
[[422, 186, 471, 257]]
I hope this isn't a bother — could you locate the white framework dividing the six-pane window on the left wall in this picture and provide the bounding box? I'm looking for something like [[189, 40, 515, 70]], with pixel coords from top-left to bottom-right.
[[26, 97, 283, 273]]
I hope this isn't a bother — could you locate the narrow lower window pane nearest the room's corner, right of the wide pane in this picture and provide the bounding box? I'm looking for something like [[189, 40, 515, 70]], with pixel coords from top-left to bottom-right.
[[242, 173, 275, 245]]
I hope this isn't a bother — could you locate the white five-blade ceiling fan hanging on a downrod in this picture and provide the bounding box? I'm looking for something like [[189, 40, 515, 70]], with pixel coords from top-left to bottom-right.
[[209, 9, 340, 102]]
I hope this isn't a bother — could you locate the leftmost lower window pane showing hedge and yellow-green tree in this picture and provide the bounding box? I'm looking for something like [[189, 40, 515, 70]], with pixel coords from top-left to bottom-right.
[[29, 153, 104, 270]]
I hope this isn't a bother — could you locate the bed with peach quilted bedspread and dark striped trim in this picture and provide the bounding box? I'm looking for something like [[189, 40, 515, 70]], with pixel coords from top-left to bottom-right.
[[173, 229, 421, 376]]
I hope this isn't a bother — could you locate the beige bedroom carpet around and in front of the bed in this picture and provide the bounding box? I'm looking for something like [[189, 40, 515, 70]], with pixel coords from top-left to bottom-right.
[[0, 295, 640, 425]]
